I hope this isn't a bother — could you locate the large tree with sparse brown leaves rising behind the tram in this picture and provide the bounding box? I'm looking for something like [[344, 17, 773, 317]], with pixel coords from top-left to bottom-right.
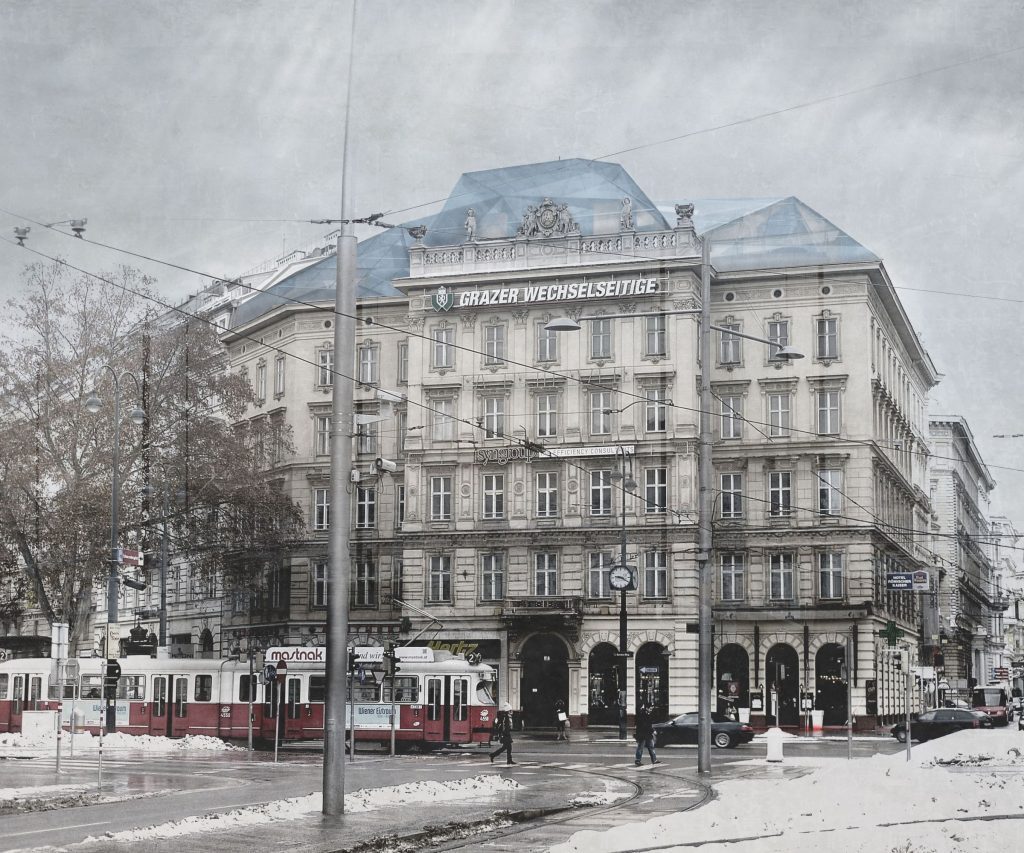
[[0, 263, 302, 639]]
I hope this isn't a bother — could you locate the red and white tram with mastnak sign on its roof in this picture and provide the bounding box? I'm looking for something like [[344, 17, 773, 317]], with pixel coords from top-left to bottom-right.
[[0, 646, 495, 749]]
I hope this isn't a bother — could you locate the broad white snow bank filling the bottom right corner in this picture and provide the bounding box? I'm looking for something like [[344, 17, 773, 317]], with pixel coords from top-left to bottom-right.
[[552, 727, 1024, 853]]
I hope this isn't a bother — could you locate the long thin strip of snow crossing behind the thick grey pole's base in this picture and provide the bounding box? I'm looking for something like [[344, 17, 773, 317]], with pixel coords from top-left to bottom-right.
[[82, 774, 519, 844]]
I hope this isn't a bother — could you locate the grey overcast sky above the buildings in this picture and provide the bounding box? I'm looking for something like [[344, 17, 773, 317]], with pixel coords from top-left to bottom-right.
[[0, 0, 1024, 527]]
